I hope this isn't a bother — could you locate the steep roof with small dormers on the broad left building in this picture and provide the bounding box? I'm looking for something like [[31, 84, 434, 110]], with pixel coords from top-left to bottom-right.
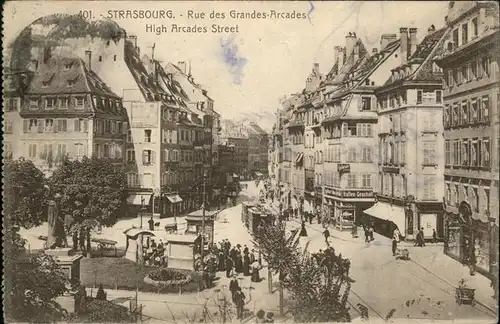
[[28, 56, 119, 99]]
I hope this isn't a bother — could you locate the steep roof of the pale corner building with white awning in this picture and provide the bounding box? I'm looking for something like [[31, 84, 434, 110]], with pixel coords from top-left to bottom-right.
[[384, 27, 448, 87]]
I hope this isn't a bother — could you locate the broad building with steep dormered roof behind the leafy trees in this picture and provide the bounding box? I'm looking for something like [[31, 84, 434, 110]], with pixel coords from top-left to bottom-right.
[[19, 55, 128, 174]]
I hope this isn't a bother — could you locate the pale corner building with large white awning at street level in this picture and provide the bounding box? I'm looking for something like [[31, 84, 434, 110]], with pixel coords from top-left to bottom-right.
[[374, 26, 447, 240]]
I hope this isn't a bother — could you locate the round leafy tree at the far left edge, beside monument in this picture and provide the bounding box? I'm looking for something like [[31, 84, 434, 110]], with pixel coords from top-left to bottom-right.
[[3, 158, 48, 228]]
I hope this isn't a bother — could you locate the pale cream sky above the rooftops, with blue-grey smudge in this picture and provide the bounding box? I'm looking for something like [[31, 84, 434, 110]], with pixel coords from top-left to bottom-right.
[[4, 1, 447, 130]]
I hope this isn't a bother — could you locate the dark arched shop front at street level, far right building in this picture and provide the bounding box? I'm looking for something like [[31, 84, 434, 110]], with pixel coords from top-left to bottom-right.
[[444, 201, 498, 277]]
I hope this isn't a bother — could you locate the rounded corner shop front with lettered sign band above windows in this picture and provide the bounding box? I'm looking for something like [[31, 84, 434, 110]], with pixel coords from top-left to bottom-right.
[[323, 187, 375, 230]]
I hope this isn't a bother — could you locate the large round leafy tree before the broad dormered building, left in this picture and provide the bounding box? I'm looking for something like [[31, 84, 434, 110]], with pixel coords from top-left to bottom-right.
[[49, 157, 127, 251]]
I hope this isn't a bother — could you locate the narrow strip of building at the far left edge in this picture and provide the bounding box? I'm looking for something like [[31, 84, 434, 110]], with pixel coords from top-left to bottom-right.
[[3, 68, 32, 160]]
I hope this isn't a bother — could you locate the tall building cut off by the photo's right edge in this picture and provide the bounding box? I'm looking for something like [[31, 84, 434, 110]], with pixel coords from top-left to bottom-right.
[[436, 1, 500, 277]]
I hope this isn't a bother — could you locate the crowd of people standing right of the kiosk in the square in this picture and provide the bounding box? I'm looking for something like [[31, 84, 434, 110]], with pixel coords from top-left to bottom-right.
[[211, 239, 262, 282]]
